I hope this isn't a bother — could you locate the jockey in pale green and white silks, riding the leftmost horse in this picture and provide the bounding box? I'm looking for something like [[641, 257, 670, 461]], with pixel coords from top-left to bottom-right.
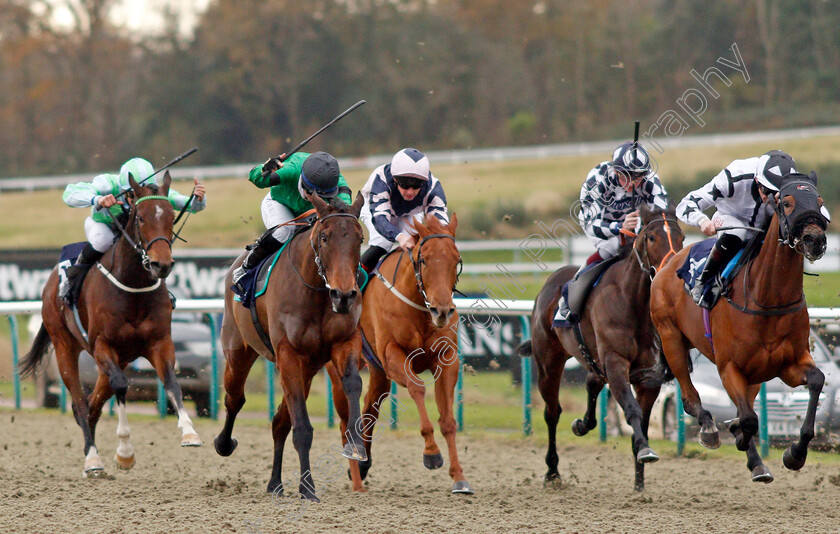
[[59, 158, 207, 305]]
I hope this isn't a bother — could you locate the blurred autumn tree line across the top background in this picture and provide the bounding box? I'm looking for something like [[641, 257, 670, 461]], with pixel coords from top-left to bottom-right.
[[0, 0, 840, 180]]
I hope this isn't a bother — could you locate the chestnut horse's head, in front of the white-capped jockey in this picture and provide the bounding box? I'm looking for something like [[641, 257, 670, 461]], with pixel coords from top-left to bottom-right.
[[411, 213, 463, 328]]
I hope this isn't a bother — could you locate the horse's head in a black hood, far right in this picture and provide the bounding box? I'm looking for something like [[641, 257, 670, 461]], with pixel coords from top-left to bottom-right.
[[775, 171, 829, 261]]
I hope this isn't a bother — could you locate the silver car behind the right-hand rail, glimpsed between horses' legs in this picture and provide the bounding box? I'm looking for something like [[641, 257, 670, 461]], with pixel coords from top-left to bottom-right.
[[607, 329, 840, 444]]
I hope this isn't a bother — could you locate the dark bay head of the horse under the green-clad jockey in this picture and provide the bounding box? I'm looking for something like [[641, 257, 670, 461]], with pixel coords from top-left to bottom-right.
[[308, 193, 364, 314]]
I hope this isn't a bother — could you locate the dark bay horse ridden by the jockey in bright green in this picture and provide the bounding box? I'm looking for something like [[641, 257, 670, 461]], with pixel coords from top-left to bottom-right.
[[215, 194, 366, 502]]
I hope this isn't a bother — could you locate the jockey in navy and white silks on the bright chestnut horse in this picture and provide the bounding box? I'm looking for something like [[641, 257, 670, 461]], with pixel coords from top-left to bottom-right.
[[359, 148, 449, 273]]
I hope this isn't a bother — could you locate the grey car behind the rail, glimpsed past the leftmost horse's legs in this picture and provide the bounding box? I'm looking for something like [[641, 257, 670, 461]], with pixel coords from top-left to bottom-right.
[[30, 312, 224, 417]]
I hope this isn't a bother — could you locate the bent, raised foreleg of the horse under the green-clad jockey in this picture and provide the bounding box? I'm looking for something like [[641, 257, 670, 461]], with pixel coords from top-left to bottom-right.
[[331, 327, 367, 462]]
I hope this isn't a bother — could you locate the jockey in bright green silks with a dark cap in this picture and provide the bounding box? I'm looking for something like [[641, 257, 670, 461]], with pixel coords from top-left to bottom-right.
[[232, 152, 352, 291]]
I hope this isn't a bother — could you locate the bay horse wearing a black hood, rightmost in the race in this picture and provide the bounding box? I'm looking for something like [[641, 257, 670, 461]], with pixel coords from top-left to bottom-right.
[[651, 172, 827, 482]]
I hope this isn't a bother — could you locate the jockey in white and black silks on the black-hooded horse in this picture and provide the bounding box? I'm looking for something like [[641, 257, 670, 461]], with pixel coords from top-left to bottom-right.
[[677, 150, 796, 309]]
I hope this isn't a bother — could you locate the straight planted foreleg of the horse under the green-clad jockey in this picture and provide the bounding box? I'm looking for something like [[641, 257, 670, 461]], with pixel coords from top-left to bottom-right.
[[272, 354, 321, 502]]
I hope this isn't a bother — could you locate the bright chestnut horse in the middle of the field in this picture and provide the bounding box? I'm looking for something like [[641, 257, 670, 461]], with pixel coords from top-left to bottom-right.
[[329, 213, 473, 494]]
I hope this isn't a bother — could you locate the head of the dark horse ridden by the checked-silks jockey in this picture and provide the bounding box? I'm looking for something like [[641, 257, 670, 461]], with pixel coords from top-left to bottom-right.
[[633, 202, 685, 277]]
